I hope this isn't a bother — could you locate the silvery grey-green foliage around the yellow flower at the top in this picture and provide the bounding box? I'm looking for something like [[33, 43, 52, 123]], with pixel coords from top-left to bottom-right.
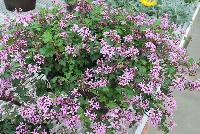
[[107, 0, 198, 29]]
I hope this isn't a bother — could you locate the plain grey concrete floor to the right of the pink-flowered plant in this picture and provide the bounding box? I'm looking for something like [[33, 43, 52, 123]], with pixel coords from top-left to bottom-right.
[[149, 3, 200, 134]]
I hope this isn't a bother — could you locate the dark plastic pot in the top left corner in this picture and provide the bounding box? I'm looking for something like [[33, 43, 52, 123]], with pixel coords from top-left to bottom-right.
[[4, 0, 36, 12]]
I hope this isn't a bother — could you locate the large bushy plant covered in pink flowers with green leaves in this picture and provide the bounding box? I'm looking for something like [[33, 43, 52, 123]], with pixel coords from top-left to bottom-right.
[[0, 0, 200, 134]]
